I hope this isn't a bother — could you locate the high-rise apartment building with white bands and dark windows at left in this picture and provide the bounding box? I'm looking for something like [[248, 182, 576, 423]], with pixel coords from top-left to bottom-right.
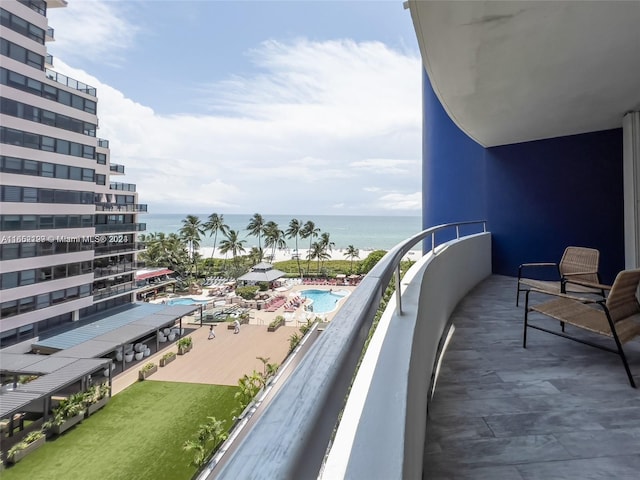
[[0, 0, 146, 346]]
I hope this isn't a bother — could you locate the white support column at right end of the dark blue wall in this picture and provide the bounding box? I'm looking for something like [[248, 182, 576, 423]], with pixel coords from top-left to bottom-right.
[[622, 112, 640, 269]]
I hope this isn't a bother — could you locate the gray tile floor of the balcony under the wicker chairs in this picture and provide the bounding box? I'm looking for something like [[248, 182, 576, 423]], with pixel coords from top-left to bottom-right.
[[424, 275, 640, 480]]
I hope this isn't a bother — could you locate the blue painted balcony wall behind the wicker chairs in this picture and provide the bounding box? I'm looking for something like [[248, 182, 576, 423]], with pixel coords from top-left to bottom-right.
[[423, 69, 624, 283]]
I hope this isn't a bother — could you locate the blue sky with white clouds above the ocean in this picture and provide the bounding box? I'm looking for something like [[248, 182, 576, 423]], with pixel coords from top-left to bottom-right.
[[47, 0, 422, 216]]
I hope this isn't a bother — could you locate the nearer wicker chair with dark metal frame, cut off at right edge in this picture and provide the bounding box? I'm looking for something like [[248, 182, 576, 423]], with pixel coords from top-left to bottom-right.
[[522, 269, 640, 388]]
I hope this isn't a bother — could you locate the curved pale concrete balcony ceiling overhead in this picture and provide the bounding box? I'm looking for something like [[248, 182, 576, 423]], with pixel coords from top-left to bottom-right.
[[408, 0, 640, 147]]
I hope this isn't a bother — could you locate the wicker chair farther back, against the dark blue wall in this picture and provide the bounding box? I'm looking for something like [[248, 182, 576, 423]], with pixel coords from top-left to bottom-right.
[[516, 247, 610, 306]]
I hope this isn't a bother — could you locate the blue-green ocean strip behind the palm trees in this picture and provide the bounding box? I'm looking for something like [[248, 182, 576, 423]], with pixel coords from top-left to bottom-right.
[[138, 213, 422, 250]]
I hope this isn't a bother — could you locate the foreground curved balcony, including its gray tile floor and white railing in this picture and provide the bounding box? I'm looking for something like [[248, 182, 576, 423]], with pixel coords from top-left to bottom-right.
[[204, 223, 640, 479]]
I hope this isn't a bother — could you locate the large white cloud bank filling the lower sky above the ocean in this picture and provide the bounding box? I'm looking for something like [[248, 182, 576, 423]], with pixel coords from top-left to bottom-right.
[[51, 38, 421, 214]]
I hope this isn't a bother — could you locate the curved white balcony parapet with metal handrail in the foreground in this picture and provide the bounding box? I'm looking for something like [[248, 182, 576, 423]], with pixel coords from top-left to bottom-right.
[[204, 221, 491, 480]]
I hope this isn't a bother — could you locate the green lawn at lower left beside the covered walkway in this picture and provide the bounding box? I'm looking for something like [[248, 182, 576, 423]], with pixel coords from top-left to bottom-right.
[[0, 381, 238, 480]]
